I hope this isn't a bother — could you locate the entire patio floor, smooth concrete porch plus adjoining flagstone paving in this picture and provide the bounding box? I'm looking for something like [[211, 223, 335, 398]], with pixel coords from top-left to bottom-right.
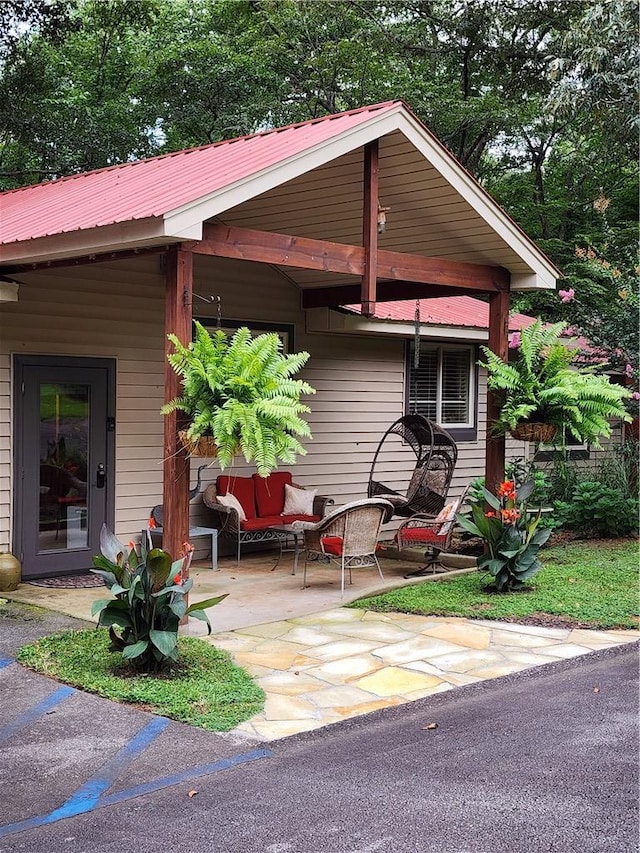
[[4, 555, 640, 741]]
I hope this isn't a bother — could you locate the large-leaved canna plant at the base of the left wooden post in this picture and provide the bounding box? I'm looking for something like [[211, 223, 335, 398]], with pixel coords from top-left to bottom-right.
[[91, 525, 227, 673]]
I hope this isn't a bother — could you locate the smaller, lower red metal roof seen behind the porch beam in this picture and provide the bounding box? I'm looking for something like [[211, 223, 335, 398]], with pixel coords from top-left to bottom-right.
[[345, 296, 535, 332]]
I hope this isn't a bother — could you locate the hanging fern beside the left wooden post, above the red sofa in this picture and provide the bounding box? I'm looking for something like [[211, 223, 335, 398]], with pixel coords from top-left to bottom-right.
[[161, 321, 315, 477]]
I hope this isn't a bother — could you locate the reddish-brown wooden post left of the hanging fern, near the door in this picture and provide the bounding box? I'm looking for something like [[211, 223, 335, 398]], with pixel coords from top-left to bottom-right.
[[162, 247, 193, 576]]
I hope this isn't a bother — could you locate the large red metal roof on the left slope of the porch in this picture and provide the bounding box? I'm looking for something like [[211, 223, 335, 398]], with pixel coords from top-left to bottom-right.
[[0, 101, 400, 244]]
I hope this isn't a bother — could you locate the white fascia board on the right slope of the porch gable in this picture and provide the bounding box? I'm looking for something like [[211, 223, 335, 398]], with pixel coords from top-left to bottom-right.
[[399, 113, 558, 290]]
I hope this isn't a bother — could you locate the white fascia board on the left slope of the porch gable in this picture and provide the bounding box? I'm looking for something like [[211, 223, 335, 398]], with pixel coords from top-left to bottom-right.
[[164, 104, 403, 239]]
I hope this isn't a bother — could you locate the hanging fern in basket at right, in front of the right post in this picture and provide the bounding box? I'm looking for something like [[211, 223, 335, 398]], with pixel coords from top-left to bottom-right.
[[479, 320, 631, 447]]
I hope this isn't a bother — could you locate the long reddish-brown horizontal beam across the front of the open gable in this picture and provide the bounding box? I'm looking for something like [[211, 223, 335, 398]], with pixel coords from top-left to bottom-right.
[[192, 224, 509, 292]]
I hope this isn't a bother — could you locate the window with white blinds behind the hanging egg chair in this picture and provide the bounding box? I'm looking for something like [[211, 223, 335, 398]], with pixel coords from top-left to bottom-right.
[[408, 343, 474, 428]]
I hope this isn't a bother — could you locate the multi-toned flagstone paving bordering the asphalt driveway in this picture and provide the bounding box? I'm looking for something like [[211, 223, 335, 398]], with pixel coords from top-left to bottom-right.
[[209, 608, 640, 741]]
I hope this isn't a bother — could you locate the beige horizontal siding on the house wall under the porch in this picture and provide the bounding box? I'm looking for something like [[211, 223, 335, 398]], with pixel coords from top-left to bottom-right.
[[0, 250, 504, 551]]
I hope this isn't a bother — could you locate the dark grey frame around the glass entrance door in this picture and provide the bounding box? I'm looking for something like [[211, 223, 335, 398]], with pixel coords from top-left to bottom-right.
[[11, 353, 116, 576]]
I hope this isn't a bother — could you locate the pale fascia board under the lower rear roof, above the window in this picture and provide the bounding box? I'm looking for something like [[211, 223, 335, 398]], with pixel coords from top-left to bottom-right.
[[305, 308, 489, 343]]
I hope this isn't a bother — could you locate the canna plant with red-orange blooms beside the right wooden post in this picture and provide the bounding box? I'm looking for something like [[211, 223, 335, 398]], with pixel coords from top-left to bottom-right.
[[456, 480, 551, 592]]
